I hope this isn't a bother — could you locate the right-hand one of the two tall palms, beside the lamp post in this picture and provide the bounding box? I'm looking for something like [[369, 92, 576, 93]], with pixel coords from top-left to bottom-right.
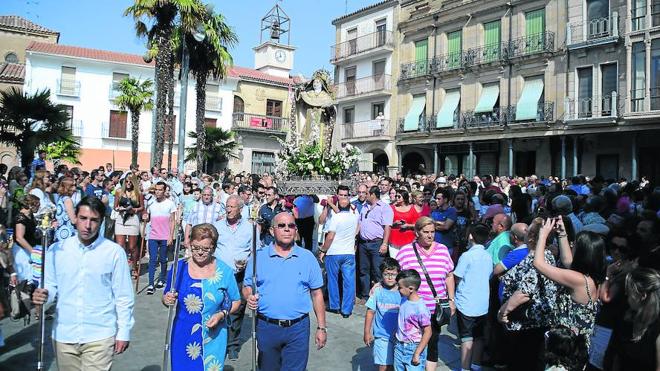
[[186, 6, 238, 169]]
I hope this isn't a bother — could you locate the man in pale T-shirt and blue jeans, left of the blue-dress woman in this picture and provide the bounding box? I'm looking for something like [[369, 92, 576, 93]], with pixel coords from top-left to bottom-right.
[[143, 182, 176, 295]]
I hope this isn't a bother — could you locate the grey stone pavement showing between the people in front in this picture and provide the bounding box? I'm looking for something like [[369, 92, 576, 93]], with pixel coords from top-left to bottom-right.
[[0, 268, 460, 371]]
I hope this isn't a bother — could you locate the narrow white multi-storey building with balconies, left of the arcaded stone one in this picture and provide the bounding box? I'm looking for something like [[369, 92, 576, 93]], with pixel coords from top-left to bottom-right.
[[330, 0, 398, 173]]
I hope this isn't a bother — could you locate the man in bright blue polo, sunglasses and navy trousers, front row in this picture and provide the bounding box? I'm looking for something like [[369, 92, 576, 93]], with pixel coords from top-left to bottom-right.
[[242, 212, 327, 371]]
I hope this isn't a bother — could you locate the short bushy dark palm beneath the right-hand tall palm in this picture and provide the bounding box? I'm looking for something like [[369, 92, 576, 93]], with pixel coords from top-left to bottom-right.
[[186, 127, 237, 172]]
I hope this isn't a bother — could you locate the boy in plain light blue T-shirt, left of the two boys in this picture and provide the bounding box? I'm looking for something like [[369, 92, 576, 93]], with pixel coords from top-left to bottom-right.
[[364, 257, 403, 371]]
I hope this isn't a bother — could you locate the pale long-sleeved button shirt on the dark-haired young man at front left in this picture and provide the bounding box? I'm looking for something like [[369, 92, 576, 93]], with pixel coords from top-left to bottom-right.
[[44, 236, 135, 344]]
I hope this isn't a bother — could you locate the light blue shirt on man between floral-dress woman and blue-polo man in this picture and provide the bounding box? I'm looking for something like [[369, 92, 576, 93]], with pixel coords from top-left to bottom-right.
[[213, 218, 252, 273]]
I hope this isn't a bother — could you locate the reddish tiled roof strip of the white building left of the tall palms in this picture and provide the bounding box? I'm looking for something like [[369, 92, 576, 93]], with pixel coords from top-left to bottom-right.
[[25, 41, 155, 67]]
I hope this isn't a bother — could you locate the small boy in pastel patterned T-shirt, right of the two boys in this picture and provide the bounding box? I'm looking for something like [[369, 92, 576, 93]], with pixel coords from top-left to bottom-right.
[[394, 269, 431, 371]]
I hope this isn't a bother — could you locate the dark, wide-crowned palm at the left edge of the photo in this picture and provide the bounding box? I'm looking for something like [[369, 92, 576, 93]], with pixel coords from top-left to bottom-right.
[[0, 87, 71, 168]]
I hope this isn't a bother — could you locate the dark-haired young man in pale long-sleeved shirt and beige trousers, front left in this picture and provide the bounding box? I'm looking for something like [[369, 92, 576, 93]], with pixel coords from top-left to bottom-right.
[[32, 197, 135, 371]]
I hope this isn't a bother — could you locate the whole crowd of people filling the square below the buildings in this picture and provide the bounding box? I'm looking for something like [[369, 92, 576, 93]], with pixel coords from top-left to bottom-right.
[[0, 154, 660, 371]]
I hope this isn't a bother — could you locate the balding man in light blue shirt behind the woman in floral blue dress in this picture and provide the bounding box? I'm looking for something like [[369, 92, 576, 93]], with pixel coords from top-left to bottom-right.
[[213, 195, 253, 360]]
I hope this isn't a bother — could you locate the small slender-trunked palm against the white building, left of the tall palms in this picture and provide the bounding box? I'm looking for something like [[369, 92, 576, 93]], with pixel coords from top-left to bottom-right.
[[115, 77, 154, 166]]
